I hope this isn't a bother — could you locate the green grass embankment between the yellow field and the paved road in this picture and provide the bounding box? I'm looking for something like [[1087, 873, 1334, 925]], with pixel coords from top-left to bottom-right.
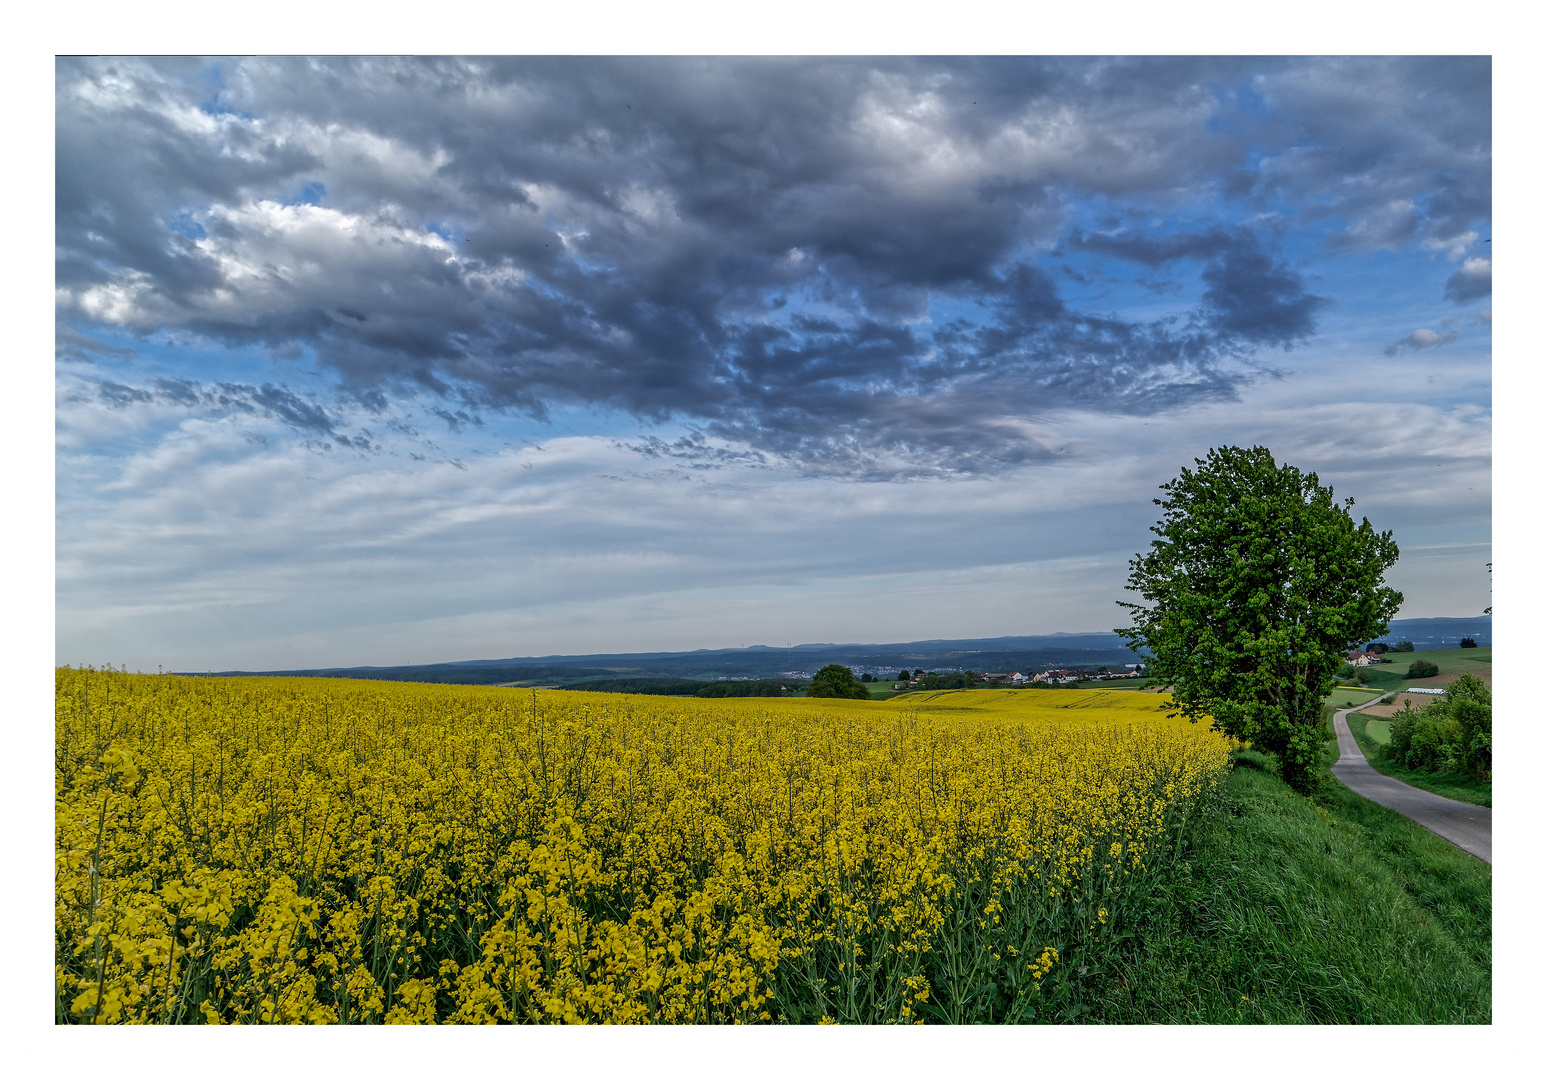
[[1089, 750, 1493, 1024]]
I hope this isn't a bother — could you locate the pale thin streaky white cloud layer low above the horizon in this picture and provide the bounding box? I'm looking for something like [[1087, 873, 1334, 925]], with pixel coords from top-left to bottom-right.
[[56, 366, 1491, 670]]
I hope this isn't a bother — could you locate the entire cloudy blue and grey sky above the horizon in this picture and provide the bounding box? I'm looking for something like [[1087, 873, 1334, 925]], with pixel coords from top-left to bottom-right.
[[54, 57, 1493, 670]]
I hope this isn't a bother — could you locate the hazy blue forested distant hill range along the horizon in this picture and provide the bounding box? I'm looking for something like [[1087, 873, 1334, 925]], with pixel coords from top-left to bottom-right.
[[190, 616, 1493, 687]]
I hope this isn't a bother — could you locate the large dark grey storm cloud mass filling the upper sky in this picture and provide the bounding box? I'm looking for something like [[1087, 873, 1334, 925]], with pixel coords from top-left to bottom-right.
[[56, 57, 1490, 475]]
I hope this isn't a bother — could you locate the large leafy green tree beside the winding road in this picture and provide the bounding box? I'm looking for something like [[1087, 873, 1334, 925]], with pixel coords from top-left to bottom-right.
[[1117, 446, 1402, 791]]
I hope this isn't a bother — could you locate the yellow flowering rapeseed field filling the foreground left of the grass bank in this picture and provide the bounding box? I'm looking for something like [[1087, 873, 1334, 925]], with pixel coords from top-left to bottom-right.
[[54, 668, 1230, 1023]]
